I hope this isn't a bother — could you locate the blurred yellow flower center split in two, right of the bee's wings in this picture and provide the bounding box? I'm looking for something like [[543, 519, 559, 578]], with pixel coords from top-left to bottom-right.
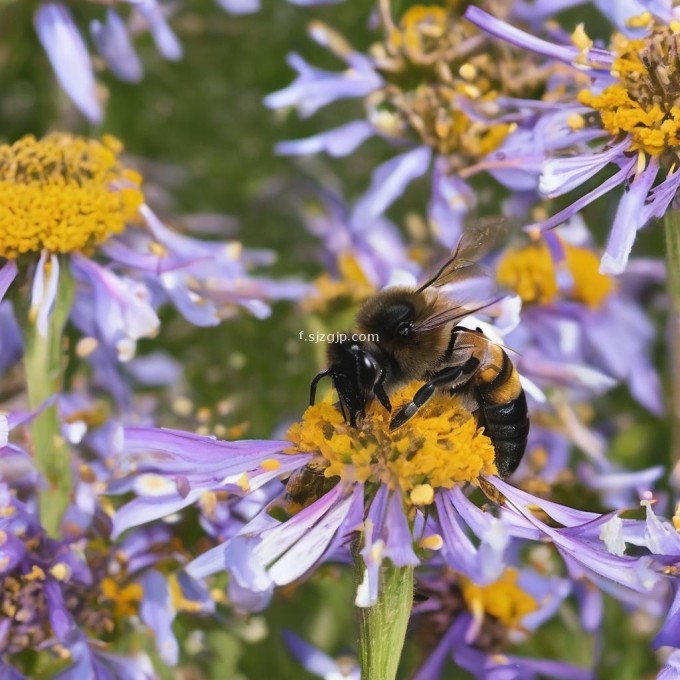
[[496, 241, 614, 308]]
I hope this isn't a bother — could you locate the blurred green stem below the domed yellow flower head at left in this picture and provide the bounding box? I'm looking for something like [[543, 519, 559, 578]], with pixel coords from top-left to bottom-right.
[[24, 260, 73, 536]]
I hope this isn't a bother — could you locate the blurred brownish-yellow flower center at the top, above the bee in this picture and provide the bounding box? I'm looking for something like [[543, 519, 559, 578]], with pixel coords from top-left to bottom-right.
[[368, 4, 546, 163]]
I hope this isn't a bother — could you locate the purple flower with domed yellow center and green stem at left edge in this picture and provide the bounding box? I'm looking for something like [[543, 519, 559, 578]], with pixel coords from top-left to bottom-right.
[[0, 133, 307, 534]]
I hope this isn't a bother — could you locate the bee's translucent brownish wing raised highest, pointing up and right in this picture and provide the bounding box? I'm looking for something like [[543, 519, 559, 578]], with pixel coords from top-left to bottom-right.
[[418, 219, 507, 293]]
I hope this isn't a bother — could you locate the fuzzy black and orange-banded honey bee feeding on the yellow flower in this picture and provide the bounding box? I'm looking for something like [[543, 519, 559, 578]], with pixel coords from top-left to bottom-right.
[[310, 228, 529, 477]]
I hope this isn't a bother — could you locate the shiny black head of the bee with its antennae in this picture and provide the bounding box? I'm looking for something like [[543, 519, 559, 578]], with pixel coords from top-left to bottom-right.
[[309, 334, 392, 427]]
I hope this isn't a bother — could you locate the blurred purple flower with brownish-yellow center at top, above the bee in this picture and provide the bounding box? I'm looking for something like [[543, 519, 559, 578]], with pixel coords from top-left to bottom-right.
[[265, 3, 546, 247]]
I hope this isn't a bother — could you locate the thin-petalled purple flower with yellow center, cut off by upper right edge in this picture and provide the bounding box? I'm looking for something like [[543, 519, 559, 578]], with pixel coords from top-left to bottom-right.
[[466, 7, 680, 274]]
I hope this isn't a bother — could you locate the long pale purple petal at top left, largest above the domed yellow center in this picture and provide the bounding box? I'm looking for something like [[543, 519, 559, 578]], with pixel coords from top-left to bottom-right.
[[34, 2, 103, 124]]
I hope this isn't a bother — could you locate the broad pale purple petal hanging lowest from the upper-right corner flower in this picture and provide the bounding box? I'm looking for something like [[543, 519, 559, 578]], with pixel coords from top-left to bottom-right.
[[600, 159, 659, 274]]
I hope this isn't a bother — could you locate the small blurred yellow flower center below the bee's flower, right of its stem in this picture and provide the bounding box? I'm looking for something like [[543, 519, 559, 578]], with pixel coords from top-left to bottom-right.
[[460, 567, 538, 628]]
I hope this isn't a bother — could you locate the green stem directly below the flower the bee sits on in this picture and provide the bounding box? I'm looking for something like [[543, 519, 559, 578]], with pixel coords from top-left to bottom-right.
[[357, 556, 413, 680]]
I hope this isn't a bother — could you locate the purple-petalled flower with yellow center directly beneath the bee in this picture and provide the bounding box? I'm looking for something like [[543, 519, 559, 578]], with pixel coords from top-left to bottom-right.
[[112, 380, 662, 610]]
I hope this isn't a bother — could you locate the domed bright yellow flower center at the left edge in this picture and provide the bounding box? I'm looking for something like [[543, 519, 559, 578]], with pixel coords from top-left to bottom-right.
[[0, 133, 144, 259]]
